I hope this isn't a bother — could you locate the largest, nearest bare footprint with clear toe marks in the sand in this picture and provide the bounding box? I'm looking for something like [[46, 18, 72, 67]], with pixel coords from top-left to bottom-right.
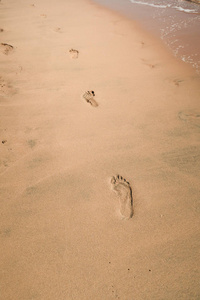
[[111, 175, 133, 219]]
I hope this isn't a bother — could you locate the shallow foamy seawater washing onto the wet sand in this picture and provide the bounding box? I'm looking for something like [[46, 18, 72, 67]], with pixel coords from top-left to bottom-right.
[[94, 0, 200, 74]]
